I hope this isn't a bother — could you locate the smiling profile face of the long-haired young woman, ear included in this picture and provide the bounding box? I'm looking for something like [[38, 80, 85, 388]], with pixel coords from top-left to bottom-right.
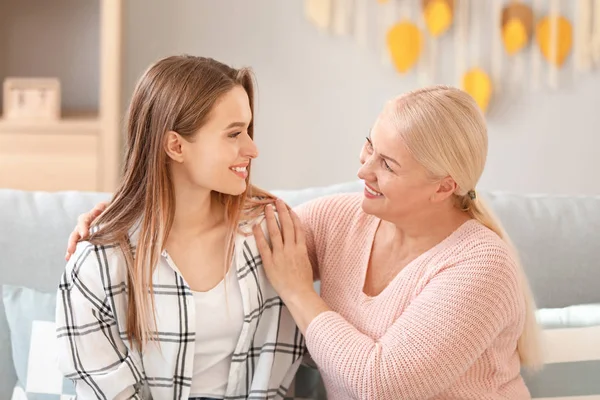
[[167, 86, 258, 196]]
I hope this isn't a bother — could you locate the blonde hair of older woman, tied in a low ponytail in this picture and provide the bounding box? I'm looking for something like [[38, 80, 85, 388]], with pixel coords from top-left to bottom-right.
[[390, 85, 542, 368]]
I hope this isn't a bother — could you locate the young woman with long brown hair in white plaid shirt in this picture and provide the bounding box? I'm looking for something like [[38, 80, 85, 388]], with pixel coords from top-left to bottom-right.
[[56, 56, 304, 399]]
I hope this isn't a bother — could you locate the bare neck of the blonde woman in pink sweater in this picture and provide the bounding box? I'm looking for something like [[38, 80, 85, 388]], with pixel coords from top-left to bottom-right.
[[381, 205, 471, 253]]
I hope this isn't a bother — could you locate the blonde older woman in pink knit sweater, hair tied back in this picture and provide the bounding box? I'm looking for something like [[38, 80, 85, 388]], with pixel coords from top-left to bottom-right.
[[64, 86, 540, 400]]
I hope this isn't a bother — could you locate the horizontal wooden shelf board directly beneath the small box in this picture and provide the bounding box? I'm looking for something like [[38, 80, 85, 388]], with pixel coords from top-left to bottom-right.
[[0, 113, 101, 135]]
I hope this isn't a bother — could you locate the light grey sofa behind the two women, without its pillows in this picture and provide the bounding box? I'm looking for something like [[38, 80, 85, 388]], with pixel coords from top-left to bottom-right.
[[0, 182, 600, 399]]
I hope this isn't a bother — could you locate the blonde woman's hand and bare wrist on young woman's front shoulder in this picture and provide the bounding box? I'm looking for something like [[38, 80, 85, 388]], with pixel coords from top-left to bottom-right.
[[253, 199, 330, 333]]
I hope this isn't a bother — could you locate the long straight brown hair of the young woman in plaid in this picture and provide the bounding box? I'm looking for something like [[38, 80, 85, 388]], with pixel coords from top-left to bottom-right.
[[89, 55, 272, 350]]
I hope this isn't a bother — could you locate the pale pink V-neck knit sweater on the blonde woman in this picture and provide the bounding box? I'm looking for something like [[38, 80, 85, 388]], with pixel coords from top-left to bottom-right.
[[297, 194, 530, 400]]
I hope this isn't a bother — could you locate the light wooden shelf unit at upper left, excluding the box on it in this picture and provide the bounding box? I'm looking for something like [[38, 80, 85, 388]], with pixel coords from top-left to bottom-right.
[[0, 0, 125, 192]]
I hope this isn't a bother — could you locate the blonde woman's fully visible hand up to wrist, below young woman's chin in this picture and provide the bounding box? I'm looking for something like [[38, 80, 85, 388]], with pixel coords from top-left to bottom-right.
[[254, 199, 314, 301]]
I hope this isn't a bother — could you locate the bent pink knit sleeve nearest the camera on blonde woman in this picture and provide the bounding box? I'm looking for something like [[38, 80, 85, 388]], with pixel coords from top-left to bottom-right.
[[306, 248, 522, 400]]
